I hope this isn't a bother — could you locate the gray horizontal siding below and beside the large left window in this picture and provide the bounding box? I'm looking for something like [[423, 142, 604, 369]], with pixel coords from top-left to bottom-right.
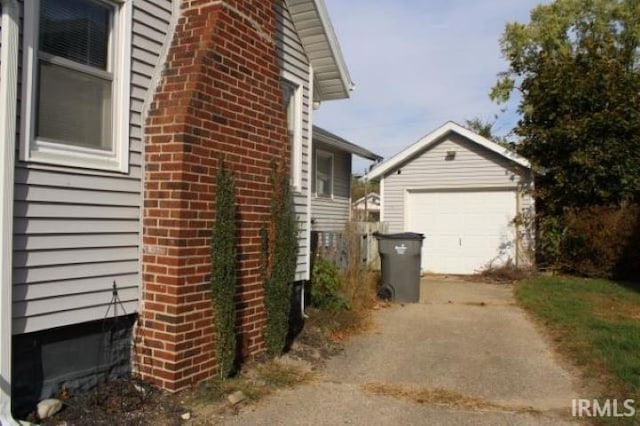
[[13, 0, 178, 333]]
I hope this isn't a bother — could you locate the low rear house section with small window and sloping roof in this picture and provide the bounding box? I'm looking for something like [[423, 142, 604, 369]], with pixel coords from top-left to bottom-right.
[[311, 126, 382, 232]]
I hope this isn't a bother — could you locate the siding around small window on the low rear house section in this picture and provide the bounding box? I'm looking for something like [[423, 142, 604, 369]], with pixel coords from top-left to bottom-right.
[[311, 141, 351, 232]]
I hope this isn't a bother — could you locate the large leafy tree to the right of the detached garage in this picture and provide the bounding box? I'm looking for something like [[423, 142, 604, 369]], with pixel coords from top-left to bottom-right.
[[491, 0, 640, 216]]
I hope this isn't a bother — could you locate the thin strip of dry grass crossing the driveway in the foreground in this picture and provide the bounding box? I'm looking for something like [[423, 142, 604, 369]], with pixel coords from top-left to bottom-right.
[[363, 383, 537, 413]]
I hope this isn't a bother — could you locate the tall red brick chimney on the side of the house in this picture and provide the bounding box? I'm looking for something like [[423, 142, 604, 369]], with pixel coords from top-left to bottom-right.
[[139, 0, 289, 391]]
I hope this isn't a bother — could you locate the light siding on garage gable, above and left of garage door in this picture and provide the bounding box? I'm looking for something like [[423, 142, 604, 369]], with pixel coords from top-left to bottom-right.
[[382, 134, 529, 232]]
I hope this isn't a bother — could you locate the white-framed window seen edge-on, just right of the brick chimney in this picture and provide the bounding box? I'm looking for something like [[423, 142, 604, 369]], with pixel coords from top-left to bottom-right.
[[282, 73, 304, 191]]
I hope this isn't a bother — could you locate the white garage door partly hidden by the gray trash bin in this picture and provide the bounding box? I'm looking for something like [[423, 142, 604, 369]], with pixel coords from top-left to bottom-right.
[[406, 191, 516, 274]]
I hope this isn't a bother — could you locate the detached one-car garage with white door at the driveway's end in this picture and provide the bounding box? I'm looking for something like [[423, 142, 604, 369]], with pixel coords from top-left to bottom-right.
[[366, 122, 533, 274]]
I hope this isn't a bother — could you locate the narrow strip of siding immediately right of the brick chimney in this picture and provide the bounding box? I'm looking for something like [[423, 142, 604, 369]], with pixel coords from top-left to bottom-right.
[[276, 2, 311, 280]]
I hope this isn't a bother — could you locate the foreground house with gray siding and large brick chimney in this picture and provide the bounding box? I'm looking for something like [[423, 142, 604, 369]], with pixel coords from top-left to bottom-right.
[[0, 0, 352, 416]]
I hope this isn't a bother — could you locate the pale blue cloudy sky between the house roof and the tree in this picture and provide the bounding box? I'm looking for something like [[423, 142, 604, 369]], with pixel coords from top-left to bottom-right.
[[314, 0, 542, 174]]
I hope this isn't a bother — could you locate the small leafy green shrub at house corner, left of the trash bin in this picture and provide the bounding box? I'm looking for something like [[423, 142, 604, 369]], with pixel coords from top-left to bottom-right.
[[311, 258, 349, 310]]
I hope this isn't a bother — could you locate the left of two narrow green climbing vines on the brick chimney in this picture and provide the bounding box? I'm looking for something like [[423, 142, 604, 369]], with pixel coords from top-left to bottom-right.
[[211, 161, 237, 378]]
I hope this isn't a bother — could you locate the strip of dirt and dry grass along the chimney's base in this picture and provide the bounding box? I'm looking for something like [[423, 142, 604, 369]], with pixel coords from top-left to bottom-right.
[[25, 323, 343, 426]]
